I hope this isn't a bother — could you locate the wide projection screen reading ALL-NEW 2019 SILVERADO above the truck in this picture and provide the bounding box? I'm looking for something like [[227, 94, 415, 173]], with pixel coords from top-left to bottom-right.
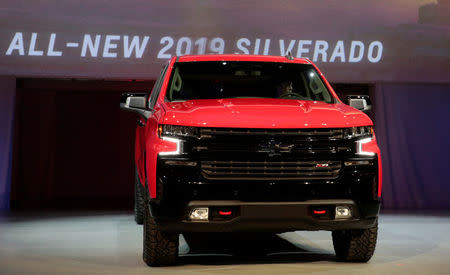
[[0, 0, 450, 82]]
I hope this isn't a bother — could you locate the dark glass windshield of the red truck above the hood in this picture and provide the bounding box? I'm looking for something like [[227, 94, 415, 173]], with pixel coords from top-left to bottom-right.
[[166, 61, 334, 103]]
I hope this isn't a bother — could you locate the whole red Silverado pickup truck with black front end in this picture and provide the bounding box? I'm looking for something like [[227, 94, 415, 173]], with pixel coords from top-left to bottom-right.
[[121, 55, 381, 266]]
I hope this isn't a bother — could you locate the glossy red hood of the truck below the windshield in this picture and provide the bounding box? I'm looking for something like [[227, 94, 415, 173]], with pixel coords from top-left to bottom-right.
[[163, 98, 372, 128]]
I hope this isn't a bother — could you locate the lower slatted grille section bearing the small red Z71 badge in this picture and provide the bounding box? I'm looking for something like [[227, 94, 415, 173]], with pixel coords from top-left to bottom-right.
[[201, 160, 342, 180]]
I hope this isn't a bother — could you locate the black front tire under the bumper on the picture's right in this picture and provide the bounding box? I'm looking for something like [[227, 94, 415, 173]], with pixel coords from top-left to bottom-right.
[[332, 221, 378, 262]]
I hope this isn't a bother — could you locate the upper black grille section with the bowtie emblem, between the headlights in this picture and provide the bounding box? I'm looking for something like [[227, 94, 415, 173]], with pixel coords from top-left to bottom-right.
[[192, 128, 354, 157]]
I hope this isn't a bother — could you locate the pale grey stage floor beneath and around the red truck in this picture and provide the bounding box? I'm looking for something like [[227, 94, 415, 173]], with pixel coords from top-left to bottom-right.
[[0, 212, 450, 275]]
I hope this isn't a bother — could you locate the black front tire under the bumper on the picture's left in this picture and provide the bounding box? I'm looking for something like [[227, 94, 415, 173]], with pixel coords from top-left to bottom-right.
[[143, 202, 179, 266]]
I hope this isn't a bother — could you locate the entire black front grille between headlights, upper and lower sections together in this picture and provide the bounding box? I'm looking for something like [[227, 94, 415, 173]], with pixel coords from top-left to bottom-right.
[[188, 128, 354, 182]]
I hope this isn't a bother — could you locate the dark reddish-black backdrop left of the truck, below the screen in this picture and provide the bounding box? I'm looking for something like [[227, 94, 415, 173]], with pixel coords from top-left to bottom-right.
[[12, 80, 153, 209]]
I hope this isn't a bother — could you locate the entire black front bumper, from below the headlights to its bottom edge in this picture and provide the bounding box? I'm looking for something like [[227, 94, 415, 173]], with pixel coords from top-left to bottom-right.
[[149, 157, 380, 233]]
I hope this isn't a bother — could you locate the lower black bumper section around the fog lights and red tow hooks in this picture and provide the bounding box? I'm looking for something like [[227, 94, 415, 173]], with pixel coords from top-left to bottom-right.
[[149, 199, 380, 233]]
